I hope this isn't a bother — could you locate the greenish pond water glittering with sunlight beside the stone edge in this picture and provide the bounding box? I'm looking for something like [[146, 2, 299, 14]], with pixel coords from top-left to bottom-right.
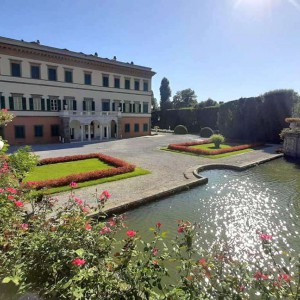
[[126, 159, 300, 260]]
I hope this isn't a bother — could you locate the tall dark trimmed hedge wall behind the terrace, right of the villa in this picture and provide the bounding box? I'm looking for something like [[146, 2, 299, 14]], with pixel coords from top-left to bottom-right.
[[152, 90, 300, 143]]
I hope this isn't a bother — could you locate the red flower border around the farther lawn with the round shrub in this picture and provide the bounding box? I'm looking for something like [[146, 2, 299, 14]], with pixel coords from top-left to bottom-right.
[[168, 140, 264, 155]]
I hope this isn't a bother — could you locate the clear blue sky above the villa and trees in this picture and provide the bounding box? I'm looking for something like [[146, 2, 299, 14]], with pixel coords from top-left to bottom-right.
[[0, 0, 300, 101]]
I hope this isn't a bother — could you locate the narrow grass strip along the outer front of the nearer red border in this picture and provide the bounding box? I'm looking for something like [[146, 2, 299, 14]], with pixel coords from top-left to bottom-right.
[[44, 168, 150, 194]]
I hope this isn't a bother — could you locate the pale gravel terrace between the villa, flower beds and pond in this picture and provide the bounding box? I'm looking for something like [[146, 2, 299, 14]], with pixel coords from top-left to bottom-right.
[[19, 133, 282, 213]]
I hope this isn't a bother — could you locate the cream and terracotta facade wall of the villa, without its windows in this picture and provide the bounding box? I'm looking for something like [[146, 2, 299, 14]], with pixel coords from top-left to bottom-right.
[[0, 37, 155, 144]]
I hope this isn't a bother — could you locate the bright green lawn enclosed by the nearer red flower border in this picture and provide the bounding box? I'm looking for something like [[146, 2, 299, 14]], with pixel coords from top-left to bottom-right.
[[24, 158, 114, 182]]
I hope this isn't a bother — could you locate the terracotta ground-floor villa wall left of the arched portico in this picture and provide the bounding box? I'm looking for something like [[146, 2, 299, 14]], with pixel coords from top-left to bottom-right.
[[4, 116, 61, 145]]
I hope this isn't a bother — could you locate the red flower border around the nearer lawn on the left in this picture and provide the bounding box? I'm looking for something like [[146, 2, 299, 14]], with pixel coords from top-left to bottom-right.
[[25, 153, 135, 189]]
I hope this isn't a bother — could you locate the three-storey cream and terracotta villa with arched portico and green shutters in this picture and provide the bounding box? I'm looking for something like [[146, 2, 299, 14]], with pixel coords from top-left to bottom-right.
[[0, 37, 155, 145]]
